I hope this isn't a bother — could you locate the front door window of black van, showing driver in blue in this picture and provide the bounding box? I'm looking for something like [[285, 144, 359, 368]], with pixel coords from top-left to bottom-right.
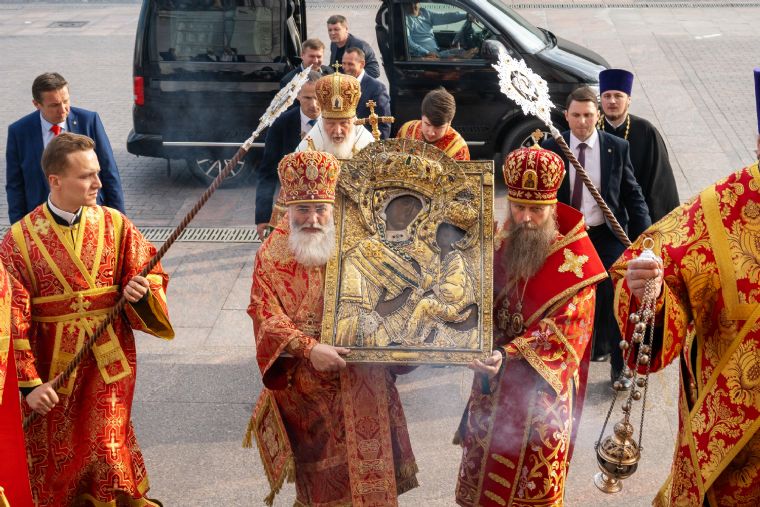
[[402, 2, 493, 60]]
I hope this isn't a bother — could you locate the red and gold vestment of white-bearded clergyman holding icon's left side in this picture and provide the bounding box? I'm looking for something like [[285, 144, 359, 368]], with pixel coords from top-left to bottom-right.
[[247, 219, 417, 507]]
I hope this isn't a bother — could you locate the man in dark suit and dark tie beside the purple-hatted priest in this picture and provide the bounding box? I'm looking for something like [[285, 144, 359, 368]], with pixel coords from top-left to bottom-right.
[[544, 86, 651, 383]]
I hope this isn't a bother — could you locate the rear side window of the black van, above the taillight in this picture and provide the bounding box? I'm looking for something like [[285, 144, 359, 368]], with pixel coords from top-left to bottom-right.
[[153, 0, 283, 62]]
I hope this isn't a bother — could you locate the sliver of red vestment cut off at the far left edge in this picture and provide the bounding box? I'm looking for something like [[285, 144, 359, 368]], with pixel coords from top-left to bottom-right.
[[0, 264, 33, 507]]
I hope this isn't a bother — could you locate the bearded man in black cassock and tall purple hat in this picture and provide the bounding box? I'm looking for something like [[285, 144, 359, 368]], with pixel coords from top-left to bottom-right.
[[598, 69, 680, 223]]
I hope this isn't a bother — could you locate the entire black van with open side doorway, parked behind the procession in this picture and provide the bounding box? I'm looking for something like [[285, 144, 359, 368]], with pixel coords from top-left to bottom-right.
[[127, 0, 608, 182]]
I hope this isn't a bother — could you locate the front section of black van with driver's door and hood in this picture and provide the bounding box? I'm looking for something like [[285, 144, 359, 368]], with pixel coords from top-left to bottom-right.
[[375, 0, 609, 162]]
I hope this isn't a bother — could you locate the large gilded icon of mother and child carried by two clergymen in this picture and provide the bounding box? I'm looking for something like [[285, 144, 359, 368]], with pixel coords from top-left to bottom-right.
[[322, 139, 493, 364]]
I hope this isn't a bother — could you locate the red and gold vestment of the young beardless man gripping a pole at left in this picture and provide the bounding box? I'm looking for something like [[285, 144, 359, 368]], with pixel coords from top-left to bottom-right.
[[0, 204, 174, 507]]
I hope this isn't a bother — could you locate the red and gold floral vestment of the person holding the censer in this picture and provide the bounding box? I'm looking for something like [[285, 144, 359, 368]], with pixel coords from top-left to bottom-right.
[[610, 163, 760, 507]]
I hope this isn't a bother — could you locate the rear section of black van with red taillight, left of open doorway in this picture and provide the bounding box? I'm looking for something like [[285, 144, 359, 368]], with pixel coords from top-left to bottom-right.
[[127, 0, 306, 182]]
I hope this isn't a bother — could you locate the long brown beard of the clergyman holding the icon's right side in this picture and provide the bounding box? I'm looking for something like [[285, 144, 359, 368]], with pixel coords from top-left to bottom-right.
[[502, 216, 557, 283]]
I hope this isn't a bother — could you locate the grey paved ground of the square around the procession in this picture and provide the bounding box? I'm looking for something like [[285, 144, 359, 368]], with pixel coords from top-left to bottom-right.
[[0, 0, 760, 507]]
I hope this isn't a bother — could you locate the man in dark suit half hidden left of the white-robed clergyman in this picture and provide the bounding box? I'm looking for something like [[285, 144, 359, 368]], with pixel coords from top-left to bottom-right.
[[255, 71, 322, 239]]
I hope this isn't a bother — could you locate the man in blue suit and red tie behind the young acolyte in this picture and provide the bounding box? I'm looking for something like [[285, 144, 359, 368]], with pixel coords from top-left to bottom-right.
[[5, 72, 124, 223]]
